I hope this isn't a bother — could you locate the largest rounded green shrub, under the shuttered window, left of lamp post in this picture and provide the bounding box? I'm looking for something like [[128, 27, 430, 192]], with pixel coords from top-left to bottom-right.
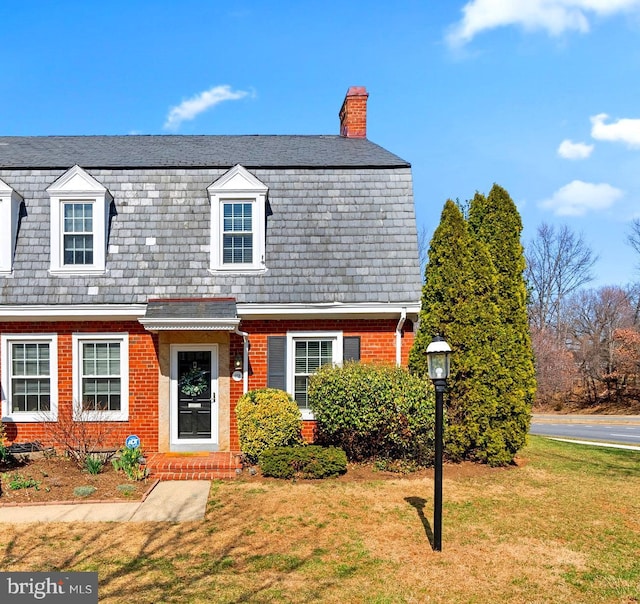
[[308, 362, 435, 466]]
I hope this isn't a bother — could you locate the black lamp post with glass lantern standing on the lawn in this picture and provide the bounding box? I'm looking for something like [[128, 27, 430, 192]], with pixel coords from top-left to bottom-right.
[[427, 336, 451, 552]]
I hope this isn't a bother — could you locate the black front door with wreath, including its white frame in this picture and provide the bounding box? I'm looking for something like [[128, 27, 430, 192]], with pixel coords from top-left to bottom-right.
[[170, 344, 218, 451]]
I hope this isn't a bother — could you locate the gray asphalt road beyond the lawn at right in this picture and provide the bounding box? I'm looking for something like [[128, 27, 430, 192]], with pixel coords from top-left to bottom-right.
[[530, 416, 640, 445]]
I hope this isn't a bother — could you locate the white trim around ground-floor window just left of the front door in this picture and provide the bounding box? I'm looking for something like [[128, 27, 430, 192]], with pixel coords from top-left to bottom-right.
[[71, 332, 129, 422]]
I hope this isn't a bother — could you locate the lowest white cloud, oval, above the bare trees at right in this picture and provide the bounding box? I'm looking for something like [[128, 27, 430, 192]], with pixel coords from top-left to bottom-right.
[[539, 180, 624, 216]]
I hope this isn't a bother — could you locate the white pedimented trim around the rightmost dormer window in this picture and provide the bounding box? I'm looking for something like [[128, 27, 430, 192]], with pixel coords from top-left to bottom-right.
[[207, 164, 268, 273]]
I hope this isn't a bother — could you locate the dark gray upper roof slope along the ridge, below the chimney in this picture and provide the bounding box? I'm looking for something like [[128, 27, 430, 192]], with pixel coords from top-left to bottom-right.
[[0, 135, 409, 169]]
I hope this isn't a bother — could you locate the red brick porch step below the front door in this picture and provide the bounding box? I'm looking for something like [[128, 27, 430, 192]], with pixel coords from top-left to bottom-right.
[[147, 451, 242, 480]]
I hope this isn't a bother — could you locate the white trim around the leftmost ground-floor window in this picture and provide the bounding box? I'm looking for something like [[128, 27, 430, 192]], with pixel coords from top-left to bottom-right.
[[0, 333, 58, 423]]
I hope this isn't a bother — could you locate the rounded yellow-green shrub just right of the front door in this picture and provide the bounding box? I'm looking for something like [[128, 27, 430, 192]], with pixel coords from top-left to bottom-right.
[[236, 388, 303, 463]]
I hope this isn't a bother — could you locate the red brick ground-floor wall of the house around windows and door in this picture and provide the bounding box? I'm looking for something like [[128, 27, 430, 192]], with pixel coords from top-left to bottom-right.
[[0, 319, 413, 452]]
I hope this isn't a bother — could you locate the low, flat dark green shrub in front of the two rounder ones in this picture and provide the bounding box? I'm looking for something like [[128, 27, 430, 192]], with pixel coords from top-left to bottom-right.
[[260, 445, 347, 478]]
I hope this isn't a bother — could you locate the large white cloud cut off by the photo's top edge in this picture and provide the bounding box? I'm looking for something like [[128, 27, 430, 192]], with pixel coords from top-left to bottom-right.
[[447, 0, 640, 47]]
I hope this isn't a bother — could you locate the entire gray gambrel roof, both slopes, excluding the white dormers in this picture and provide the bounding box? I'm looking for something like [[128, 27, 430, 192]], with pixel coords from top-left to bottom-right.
[[0, 137, 421, 305]]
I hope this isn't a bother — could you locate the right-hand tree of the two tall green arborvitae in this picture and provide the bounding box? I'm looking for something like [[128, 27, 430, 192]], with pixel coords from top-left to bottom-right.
[[468, 184, 536, 454]]
